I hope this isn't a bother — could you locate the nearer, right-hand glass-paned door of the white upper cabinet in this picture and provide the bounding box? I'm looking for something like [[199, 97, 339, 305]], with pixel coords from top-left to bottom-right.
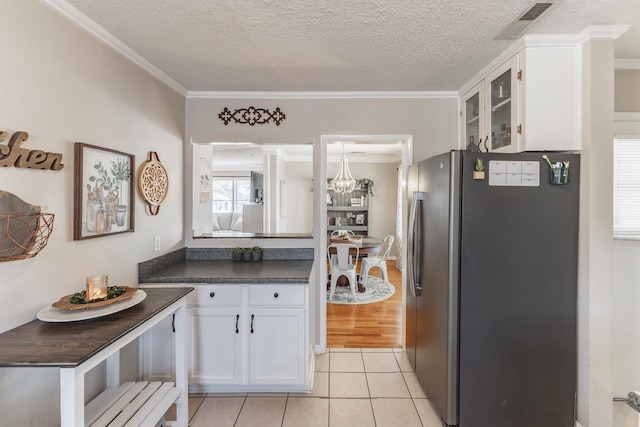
[[487, 54, 518, 152]]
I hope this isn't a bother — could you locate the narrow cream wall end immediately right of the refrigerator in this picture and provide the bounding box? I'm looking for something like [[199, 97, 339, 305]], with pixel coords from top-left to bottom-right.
[[577, 40, 614, 427]]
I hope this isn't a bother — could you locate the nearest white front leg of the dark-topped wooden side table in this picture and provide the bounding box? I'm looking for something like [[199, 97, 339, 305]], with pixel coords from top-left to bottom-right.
[[60, 368, 84, 427]]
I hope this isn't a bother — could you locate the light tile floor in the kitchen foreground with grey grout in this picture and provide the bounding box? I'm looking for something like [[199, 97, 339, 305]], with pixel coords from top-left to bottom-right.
[[181, 349, 442, 427]]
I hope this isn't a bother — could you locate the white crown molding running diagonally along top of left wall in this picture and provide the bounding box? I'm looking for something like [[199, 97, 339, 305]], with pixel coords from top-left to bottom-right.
[[42, 0, 187, 96]]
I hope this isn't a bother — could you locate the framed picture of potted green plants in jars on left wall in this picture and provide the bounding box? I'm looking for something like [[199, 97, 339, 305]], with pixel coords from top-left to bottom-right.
[[73, 142, 135, 240]]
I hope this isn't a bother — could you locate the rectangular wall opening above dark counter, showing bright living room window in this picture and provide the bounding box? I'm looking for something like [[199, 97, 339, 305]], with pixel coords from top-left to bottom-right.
[[193, 143, 313, 238]]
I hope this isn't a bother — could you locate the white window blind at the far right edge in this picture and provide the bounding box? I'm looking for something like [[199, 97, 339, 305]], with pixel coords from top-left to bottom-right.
[[613, 138, 640, 239]]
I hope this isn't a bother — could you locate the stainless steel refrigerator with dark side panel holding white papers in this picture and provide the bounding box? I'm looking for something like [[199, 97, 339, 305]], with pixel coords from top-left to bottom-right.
[[405, 151, 580, 427]]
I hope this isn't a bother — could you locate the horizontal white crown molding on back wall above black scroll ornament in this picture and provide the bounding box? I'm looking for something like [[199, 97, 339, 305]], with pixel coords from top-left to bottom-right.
[[187, 91, 458, 99]]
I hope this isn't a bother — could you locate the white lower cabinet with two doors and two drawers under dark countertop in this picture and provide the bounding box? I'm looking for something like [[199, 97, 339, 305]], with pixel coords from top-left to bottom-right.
[[187, 284, 311, 392]]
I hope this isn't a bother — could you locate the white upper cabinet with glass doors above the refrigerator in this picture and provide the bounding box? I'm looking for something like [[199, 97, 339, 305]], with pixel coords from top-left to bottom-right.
[[460, 45, 581, 153]]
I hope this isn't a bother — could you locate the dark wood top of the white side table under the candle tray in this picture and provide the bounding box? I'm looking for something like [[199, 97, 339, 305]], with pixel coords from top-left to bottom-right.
[[0, 287, 193, 367]]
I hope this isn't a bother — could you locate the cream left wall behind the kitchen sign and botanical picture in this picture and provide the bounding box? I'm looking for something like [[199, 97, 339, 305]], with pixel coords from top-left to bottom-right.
[[0, 0, 184, 427]]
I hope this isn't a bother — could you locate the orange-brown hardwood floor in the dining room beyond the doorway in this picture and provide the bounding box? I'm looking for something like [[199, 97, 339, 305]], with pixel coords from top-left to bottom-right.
[[327, 261, 403, 348]]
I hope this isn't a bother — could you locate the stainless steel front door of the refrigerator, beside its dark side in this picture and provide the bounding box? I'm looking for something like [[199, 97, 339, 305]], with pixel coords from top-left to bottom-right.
[[416, 152, 459, 425]]
